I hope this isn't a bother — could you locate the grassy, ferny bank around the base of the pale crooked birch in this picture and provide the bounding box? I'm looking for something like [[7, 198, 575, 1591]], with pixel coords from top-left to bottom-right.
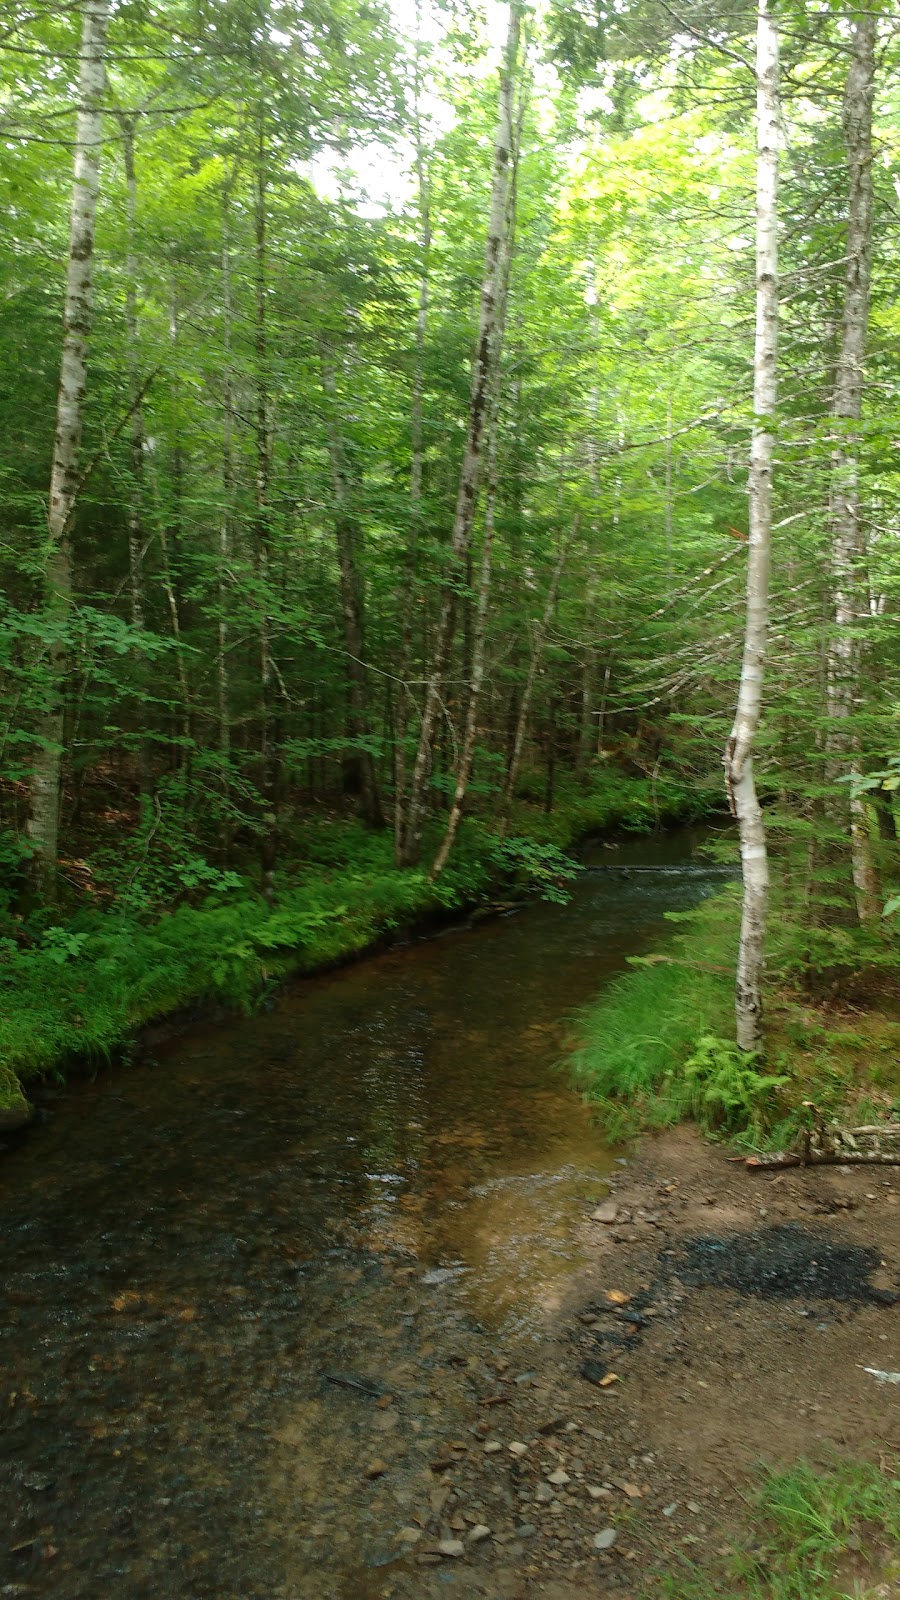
[[573, 885, 900, 1149]]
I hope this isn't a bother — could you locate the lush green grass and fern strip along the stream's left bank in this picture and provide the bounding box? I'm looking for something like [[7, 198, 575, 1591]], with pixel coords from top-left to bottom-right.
[[0, 773, 709, 1126]]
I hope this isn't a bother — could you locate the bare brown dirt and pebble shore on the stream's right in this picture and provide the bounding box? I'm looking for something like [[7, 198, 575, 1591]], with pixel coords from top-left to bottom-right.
[[344, 1126, 900, 1600]]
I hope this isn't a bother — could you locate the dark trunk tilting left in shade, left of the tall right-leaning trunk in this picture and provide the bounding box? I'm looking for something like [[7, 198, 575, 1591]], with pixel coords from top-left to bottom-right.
[[322, 365, 384, 827]]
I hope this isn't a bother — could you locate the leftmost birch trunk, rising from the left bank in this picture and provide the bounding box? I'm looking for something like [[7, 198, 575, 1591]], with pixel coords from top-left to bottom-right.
[[27, 0, 109, 898]]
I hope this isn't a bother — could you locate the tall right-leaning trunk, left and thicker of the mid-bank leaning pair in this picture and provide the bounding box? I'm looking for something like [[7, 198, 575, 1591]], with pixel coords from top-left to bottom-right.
[[399, 0, 522, 866]]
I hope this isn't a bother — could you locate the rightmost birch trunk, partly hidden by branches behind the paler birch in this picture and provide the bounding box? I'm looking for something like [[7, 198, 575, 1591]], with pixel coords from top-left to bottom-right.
[[826, 10, 881, 923]]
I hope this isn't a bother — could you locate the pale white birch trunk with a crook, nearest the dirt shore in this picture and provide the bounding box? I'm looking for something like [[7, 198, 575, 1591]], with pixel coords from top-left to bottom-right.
[[724, 0, 778, 1051]]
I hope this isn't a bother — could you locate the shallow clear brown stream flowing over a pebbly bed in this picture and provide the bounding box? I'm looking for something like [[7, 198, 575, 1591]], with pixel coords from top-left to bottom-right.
[[0, 832, 722, 1600]]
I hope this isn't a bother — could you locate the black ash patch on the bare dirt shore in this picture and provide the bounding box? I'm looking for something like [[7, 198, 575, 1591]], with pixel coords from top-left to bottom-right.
[[669, 1222, 900, 1306]]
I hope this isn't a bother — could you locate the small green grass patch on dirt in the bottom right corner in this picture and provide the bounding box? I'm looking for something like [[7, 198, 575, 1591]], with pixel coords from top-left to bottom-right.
[[653, 1461, 900, 1600]]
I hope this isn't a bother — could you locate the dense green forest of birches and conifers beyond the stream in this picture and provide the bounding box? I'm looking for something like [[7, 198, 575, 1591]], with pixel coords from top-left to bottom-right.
[[0, 0, 900, 1118]]
